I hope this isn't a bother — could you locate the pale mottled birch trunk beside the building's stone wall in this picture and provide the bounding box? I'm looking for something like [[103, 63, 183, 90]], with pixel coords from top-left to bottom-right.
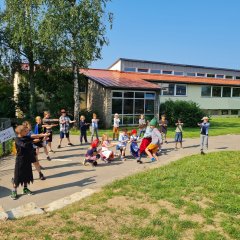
[[72, 62, 80, 127]]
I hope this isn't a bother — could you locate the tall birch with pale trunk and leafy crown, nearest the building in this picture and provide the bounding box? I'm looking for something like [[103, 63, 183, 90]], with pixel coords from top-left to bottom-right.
[[40, 0, 112, 122]]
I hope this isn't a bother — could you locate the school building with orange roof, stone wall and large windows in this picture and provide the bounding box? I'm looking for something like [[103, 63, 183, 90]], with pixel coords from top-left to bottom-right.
[[80, 58, 240, 127]]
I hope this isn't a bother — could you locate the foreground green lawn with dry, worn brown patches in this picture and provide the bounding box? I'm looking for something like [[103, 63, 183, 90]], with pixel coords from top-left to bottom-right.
[[0, 151, 240, 240]]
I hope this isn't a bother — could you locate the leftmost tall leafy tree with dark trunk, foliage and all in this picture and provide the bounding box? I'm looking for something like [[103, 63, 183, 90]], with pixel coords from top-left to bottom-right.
[[0, 0, 45, 116]]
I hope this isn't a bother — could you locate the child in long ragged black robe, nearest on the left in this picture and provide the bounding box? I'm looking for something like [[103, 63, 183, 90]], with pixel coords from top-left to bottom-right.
[[11, 125, 35, 200]]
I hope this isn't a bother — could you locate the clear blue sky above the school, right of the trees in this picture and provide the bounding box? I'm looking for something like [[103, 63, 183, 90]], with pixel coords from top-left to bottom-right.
[[91, 0, 240, 69]]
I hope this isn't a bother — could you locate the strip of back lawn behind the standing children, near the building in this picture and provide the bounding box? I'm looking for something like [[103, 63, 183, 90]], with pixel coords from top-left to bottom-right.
[[71, 117, 240, 138]]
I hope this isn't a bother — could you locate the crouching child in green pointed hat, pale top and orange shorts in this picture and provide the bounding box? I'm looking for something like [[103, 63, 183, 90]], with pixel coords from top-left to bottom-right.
[[145, 118, 162, 162]]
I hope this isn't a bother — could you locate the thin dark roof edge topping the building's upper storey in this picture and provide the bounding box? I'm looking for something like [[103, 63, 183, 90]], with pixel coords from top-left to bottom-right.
[[108, 58, 240, 73]]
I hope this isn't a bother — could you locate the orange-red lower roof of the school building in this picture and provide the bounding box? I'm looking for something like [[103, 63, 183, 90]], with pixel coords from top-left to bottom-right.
[[80, 69, 240, 89]]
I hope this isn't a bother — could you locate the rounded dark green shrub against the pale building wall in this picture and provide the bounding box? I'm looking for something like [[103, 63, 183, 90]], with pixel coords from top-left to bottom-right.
[[160, 99, 204, 127]]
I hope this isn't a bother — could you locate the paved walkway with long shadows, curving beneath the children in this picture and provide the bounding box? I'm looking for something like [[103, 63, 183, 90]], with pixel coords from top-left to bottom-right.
[[0, 135, 240, 210]]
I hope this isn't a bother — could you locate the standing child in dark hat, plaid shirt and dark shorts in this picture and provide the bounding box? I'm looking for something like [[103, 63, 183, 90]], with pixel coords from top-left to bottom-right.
[[58, 109, 76, 148]]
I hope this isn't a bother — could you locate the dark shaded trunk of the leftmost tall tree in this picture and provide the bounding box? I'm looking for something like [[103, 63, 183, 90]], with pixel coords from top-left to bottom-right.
[[29, 58, 36, 118]]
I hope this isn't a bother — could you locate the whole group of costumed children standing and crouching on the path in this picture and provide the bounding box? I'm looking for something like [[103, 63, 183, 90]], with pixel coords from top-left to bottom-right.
[[11, 109, 210, 199]]
